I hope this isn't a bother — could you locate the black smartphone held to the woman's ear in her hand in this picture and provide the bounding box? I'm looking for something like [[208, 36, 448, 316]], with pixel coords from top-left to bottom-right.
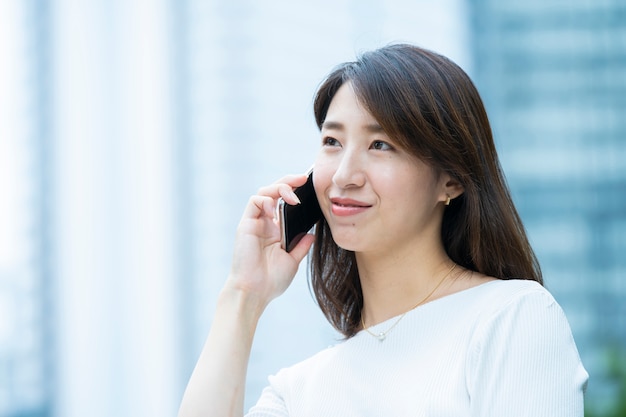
[[278, 170, 322, 252]]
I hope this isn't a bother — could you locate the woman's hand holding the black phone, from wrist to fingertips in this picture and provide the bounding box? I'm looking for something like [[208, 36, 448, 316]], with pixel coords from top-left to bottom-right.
[[226, 175, 314, 310]]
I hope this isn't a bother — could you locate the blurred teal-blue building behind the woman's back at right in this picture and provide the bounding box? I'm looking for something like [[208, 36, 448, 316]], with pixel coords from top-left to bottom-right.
[[470, 0, 626, 402]]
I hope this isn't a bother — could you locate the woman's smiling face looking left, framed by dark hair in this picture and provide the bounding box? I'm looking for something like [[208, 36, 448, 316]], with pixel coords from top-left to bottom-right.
[[313, 79, 449, 254]]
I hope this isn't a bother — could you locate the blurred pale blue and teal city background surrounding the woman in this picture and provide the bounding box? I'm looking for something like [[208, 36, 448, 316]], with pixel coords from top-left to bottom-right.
[[0, 0, 626, 417]]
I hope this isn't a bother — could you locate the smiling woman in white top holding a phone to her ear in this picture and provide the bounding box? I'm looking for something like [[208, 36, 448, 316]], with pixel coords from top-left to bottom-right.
[[180, 45, 587, 417]]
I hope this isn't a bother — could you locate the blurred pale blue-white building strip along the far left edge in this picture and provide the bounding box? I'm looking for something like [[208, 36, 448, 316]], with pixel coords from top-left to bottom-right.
[[0, 1, 53, 417]]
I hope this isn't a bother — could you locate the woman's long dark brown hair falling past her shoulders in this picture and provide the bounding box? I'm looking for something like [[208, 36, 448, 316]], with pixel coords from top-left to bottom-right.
[[310, 44, 543, 337]]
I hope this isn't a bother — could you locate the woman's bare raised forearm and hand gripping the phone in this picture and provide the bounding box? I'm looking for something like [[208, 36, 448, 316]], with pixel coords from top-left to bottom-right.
[[178, 175, 313, 417]]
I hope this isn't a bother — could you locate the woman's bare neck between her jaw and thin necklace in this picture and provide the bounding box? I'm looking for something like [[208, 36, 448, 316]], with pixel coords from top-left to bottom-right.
[[356, 242, 454, 326]]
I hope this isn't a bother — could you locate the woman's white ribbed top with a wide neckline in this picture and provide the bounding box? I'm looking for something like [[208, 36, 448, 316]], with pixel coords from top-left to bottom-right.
[[248, 280, 588, 417]]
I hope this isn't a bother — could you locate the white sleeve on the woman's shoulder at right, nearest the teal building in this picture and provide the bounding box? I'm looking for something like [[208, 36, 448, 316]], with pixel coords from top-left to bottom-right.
[[466, 287, 588, 417]]
